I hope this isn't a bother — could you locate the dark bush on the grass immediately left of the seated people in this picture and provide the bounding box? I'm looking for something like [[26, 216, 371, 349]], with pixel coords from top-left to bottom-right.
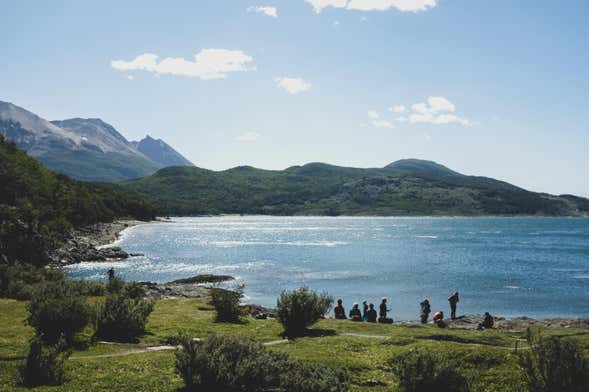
[[276, 287, 333, 337]]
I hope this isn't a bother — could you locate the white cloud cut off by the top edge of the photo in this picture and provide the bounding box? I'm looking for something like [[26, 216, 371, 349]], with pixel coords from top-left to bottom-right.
[[305, 0, 437, 13]]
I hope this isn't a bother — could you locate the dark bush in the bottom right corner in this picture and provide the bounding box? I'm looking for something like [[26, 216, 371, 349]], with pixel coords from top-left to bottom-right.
[[519, 330, 589, 392]]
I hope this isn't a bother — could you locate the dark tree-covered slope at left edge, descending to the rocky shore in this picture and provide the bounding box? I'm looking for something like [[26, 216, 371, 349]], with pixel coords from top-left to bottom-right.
[[0, 135, 154, 265]]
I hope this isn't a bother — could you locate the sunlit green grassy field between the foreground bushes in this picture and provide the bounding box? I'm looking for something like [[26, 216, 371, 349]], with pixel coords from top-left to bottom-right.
[[0, 299, 589, 391]]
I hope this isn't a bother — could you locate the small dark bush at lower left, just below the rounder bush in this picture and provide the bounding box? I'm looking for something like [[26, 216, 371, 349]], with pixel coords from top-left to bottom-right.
[[19, 336, 70, 387]]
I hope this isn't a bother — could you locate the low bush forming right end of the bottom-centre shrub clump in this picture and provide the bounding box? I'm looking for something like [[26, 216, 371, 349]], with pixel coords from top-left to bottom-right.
[[280, 361, 348, 392]]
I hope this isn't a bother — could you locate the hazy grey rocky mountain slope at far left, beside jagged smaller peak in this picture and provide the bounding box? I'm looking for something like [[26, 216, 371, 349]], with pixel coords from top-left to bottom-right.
[[0, 101, 191, 181]]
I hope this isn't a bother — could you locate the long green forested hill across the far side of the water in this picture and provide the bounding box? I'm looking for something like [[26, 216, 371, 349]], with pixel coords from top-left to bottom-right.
[[122, 159, 589, 216]]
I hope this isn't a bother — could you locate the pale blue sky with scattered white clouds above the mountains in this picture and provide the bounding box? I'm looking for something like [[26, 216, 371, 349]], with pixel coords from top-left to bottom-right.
[[0, 0, 589, 196]]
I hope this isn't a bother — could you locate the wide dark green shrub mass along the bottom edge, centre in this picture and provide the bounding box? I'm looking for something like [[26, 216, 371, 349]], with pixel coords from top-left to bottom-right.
[[176, 335, 347, 392]]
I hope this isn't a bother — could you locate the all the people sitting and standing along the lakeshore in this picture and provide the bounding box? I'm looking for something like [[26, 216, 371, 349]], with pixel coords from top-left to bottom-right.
[[333, 292, 493, 329]]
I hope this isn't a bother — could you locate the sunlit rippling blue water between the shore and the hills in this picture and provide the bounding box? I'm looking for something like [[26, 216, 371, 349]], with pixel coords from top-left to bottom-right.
[[68, 217, 589, 320]]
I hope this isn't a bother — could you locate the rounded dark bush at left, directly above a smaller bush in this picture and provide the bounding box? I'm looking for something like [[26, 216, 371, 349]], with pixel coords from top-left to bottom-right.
[[27, 281, 90, 344]]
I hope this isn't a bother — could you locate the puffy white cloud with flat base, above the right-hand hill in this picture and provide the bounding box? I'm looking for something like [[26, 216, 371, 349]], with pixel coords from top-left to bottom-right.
[[400, 97, 472, 126]]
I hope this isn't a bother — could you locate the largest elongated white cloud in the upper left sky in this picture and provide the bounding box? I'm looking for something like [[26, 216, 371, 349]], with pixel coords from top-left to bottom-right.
[[110, 49, 255, 80]]
